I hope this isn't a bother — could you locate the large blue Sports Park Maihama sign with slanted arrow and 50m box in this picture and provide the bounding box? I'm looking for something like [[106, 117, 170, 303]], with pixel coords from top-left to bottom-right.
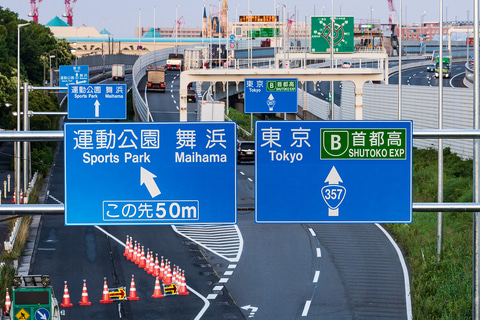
[[64, 122, 237, 225]]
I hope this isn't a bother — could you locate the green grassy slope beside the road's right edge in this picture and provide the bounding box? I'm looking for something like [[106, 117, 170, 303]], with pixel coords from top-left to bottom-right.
[[386, 148, 473, 319]]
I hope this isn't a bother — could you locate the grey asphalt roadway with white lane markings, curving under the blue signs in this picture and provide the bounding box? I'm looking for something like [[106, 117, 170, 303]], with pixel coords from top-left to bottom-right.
[[31, 67, 411, 319]]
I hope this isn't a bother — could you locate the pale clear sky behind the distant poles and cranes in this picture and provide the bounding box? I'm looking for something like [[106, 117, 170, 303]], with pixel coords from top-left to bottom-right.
[[0, 0, 474, 37]]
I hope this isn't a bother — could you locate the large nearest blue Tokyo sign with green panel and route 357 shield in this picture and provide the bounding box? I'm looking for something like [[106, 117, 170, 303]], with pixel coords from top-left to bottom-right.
[[255, 121, 412, 223]]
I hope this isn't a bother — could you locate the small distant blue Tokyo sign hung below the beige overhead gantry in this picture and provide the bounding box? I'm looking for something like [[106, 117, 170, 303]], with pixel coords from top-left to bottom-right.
[[245, 79, 298, 113]]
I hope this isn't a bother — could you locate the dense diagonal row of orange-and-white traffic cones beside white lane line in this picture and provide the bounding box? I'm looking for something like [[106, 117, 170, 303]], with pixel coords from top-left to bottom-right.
[[123, 235, 189, 295]]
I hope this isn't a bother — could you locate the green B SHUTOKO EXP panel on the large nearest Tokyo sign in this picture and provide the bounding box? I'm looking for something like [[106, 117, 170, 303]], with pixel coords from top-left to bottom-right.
[[320, 128, 407, 160]]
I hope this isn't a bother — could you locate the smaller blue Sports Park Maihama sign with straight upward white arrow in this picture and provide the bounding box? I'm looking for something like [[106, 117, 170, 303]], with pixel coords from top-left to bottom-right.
[[68, 84, 127, 120]]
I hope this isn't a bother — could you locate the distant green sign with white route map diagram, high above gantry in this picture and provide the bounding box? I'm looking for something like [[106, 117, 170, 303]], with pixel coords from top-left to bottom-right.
[[311, 17, 355, 53]]
